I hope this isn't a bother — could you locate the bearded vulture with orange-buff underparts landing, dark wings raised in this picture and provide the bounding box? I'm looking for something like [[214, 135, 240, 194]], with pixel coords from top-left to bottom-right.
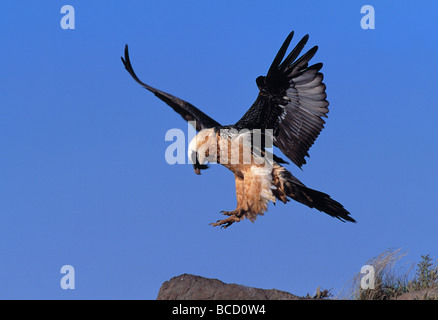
[[122, 31, 356, 228]]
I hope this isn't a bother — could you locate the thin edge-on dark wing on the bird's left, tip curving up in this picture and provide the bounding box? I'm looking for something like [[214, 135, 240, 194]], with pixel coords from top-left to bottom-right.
[[122, 45, 220, 131]]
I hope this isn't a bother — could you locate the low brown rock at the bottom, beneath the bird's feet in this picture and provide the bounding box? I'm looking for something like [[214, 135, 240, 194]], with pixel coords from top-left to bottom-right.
[[157, 274, 305, 300]]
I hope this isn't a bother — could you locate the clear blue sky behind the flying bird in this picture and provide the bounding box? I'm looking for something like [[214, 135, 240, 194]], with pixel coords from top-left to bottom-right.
[[0, 0, 438, 299]]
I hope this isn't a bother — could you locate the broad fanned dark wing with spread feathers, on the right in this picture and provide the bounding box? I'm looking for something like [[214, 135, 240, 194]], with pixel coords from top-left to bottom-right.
[[235, 32, 329, 167]]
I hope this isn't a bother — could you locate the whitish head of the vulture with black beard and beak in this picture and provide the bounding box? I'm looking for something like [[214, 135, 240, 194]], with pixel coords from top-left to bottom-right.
[[189, 129, 217, 174]]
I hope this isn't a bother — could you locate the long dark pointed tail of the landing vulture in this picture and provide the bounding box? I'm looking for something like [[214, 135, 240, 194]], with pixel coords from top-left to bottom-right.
[[273, 165, 356, 223]]
